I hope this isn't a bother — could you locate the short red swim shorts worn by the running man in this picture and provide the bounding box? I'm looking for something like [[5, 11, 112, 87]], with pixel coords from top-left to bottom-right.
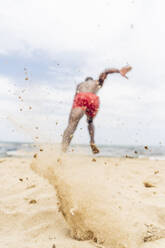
[[72, 92, 99, 117]]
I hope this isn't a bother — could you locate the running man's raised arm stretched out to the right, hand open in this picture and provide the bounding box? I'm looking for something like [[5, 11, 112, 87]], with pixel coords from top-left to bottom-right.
[[98, 66, 132, 86]]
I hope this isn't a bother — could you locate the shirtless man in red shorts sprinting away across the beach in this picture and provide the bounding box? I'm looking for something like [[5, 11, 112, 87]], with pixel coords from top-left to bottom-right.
[[62, 66, 131, 153]]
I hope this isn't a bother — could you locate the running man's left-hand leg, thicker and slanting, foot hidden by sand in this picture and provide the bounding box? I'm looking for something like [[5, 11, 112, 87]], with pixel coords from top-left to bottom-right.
[[62, 108, 84, 152]]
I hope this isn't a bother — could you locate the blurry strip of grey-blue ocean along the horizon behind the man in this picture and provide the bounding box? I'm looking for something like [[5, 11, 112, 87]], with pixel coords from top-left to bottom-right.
[[0, 142, 165, 160]]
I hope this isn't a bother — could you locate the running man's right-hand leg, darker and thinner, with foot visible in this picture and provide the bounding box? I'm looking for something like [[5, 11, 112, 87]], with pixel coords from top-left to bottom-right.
[[87, 117, 99, 153]]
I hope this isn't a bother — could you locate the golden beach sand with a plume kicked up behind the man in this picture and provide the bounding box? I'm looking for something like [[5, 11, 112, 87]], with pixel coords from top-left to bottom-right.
[[0, 148, 165, 248]]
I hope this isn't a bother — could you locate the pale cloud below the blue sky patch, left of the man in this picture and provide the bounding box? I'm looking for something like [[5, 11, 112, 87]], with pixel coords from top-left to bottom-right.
[[0, 76, 74, 142]]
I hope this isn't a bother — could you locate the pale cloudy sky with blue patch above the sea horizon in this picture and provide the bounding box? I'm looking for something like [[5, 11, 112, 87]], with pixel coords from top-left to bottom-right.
[[0, 0, 165, 145]]
